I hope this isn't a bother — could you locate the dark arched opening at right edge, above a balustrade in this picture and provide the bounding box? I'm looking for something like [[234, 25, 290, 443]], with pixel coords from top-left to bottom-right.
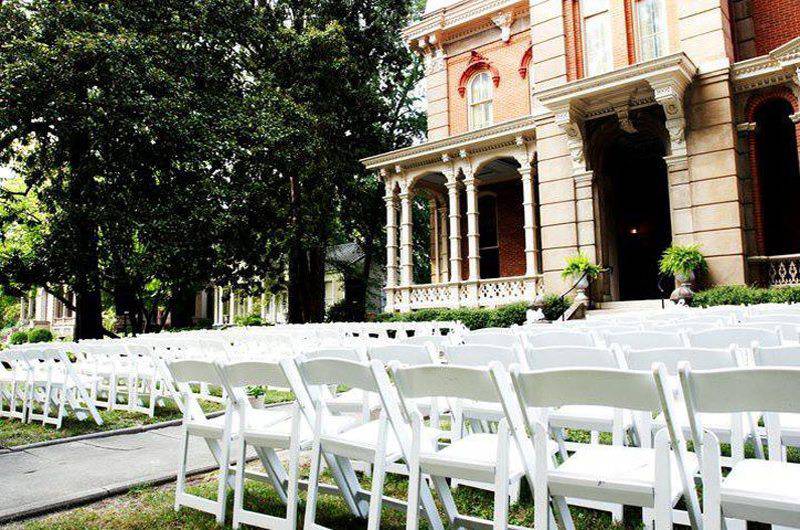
[[755, 99, 800, 256]]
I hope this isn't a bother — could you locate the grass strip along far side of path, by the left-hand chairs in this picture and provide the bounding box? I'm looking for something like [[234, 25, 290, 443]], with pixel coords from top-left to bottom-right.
[[0, 390, 294, 449]]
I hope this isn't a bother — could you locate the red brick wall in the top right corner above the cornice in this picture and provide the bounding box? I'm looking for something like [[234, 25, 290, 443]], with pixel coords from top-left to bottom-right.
[[752, 0, 800, 55]]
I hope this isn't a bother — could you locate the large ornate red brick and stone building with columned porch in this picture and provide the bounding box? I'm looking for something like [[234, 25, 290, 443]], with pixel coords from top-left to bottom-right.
[[364, 0, 800, 310]]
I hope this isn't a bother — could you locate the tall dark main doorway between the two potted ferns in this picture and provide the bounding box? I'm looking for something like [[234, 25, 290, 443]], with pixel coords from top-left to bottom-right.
[[599, 133, 672, 300]]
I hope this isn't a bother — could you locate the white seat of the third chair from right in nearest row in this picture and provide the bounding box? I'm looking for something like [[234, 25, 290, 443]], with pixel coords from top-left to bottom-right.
[[420, 433, 558, 482]]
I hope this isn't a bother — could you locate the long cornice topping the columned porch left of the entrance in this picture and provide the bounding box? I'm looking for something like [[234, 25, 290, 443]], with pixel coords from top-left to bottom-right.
[[361, 116, 536, 169]]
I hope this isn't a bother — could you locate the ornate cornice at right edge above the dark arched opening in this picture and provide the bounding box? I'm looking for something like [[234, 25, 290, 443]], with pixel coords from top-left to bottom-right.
[[732, 37, 800, 93]]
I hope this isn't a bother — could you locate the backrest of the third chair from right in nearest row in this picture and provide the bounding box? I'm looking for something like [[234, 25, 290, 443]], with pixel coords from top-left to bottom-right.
[[391, 364, 500, 403]]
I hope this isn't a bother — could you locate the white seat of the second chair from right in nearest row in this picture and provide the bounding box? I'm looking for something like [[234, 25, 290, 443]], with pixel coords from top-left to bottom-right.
[[548, 445, 698, 508]]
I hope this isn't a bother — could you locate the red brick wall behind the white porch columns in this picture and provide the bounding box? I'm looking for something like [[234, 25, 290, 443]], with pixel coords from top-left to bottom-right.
[[461, 180, 525, 280]]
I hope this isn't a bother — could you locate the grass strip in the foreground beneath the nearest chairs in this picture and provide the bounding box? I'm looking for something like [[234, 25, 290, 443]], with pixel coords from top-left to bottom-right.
[[7, 460, 620, 530]]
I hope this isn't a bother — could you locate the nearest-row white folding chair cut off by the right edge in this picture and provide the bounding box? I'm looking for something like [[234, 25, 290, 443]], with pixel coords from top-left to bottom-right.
[[671, 363, 800, 530]]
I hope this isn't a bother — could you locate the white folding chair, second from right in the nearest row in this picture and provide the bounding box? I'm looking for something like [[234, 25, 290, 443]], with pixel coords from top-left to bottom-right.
[[511, 368, 699, 530]]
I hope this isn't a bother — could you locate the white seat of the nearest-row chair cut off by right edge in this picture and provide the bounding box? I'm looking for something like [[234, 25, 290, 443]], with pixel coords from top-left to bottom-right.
[[720, 459, 800, 527]]
